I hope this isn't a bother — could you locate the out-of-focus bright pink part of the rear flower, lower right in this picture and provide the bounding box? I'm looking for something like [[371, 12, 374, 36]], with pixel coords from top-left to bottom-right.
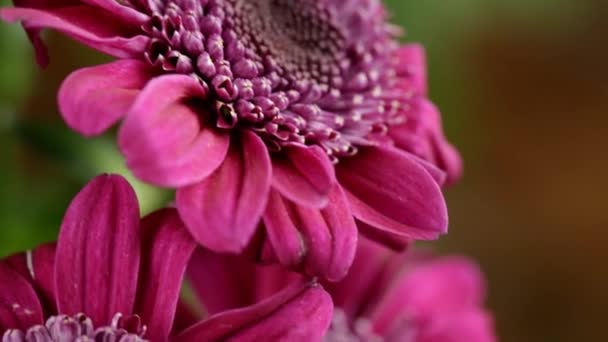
[[325, 241, 496, 342]]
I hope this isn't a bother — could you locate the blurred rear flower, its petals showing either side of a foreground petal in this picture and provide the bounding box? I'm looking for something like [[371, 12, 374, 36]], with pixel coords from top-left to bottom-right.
[[187, 238, 497, 342]]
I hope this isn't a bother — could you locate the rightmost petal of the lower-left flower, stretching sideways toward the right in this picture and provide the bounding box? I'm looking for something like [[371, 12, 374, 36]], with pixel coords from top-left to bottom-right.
[[173, 283, 333, 342]]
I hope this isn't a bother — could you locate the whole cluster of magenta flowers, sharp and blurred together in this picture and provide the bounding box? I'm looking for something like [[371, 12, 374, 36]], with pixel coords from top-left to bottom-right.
[[0, 0, 494, 342]]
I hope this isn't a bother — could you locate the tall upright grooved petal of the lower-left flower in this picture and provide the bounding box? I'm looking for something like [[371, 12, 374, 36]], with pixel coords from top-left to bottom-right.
[[55, 175, 140, 324]]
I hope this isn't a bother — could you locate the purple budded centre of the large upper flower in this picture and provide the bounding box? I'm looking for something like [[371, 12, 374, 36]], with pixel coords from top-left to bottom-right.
[[130, 0, 411, 161]]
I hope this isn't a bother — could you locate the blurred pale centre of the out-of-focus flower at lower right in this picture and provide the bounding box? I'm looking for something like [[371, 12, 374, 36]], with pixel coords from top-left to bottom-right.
[[324, 308, 384, 342]]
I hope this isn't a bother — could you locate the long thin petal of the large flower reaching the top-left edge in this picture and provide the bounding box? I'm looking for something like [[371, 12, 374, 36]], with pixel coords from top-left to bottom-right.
[[0, 6, 150, 58]]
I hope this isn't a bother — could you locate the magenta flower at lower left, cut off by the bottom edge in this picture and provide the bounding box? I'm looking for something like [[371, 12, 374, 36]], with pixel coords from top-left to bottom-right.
[[0, 176, 332, 342]]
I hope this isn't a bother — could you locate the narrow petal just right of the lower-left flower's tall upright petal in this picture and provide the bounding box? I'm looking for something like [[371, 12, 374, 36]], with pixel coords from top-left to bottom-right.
[[135, 209, 196, 341]]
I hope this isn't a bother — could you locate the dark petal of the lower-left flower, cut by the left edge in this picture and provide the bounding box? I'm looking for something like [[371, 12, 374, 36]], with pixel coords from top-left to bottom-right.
[[0, 261, 43, 336]]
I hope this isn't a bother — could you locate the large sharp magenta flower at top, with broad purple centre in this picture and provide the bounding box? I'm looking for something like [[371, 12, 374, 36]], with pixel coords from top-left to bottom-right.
[[0, 0, 460, 280]]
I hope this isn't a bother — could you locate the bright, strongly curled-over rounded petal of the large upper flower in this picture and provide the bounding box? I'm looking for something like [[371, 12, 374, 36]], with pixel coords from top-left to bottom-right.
[[118, 75, 230, 187]]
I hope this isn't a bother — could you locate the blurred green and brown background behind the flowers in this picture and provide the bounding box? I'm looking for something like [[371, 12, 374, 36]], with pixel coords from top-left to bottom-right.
[[0, 0, 608, 342]]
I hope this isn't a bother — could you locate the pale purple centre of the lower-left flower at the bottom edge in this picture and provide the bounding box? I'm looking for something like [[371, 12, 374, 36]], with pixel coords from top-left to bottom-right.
[[2, 313, 147, 342]]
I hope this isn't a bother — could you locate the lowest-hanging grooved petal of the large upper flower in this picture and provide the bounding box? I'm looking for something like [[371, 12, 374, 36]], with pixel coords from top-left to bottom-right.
[[264, 185, 357, 281]]
